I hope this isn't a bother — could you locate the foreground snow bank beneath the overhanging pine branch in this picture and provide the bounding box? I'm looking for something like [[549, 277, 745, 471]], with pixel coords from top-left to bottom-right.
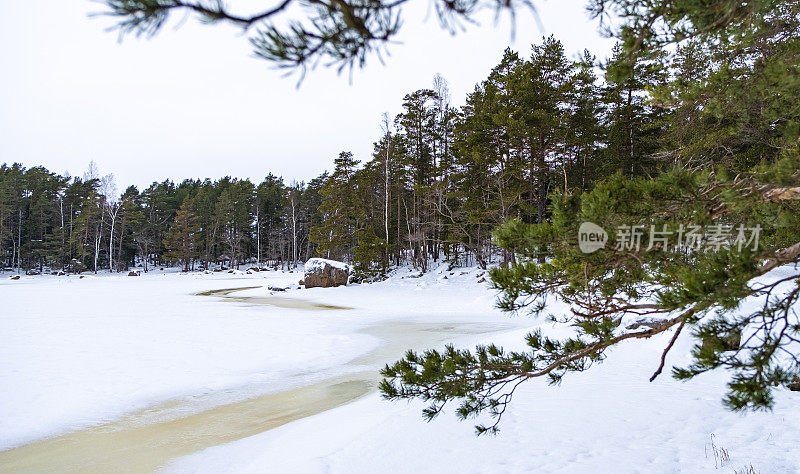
[[165, 268, 800, 473]]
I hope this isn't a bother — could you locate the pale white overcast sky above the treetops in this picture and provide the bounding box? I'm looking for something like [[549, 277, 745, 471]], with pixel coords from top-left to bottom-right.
[[0, 0, 613, 189]]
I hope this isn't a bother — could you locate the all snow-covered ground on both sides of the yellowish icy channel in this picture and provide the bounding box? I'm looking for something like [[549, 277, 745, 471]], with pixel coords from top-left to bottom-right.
[[0, 267, 800, 473]]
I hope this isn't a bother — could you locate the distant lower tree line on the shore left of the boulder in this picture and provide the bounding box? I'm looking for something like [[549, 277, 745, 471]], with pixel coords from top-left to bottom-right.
[[0, 163, 325, 272]]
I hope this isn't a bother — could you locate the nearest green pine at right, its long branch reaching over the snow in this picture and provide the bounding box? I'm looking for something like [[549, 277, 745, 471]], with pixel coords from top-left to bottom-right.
[[380, 0, 800, 433]]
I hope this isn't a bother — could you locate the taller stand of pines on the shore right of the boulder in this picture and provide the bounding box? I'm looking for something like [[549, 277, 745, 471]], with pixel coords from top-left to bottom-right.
[[311, 37, 676, 273]]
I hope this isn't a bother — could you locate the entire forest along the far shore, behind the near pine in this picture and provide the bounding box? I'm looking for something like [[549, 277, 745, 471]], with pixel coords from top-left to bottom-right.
[[0, 37, 760, 276]]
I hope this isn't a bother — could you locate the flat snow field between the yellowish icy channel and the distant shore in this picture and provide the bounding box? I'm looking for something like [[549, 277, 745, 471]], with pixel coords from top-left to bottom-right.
[[0, 262, 521, 450]]
